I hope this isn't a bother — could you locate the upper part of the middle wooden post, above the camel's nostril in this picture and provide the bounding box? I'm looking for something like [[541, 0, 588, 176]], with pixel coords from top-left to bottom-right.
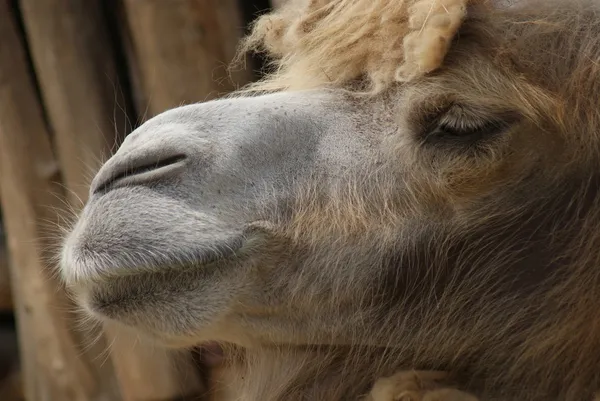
[[20, 0, 128, 208]]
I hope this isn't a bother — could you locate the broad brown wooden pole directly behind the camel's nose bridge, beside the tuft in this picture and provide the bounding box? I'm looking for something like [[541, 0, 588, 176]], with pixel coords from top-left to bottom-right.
[[124, 0, 252, 119]]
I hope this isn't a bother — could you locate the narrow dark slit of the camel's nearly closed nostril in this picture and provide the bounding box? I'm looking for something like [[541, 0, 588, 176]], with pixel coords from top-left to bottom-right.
[[92, 154, 186, 194]]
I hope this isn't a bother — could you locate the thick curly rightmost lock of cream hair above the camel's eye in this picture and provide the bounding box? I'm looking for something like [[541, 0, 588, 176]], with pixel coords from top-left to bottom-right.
[[395, 0, 473, 82]]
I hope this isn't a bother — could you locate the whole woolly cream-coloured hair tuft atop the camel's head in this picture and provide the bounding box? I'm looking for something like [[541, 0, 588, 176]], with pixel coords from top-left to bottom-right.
[[243, 0, 472, 93]]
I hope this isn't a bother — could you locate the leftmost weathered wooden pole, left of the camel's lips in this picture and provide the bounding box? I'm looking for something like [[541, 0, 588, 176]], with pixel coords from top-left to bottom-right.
[[0, 1, 118, 401]]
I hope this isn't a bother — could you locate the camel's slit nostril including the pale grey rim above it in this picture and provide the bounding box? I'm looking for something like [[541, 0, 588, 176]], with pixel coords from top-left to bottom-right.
[[90, 148, 187, 195]]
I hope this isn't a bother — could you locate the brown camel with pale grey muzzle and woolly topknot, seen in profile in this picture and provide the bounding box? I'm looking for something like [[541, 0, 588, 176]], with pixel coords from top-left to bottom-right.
[[60, 0, 600, 401]]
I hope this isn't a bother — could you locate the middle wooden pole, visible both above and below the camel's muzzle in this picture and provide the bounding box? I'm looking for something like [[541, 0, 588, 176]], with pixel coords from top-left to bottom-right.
[[21, 0, 202, 401]]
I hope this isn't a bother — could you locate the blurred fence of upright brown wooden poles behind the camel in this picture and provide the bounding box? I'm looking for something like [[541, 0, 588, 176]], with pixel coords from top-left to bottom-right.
[[0, 0, 281, 401]]
